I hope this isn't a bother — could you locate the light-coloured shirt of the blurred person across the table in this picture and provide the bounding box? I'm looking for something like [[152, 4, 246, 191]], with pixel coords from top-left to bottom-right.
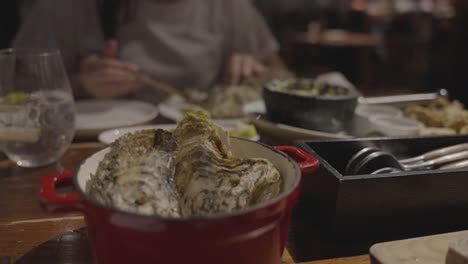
[[14, 0, 278, 100]]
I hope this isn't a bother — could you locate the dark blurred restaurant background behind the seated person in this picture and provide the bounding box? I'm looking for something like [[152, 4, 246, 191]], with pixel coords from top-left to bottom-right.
[[0, 0, 468, 101]]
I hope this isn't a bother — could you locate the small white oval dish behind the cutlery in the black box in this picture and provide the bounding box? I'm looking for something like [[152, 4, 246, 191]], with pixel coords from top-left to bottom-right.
[[370, 116, 424, 136]]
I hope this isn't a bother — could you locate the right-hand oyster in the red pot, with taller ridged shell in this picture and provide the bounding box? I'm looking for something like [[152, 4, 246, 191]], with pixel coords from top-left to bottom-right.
[[174, 112, 281, 216]]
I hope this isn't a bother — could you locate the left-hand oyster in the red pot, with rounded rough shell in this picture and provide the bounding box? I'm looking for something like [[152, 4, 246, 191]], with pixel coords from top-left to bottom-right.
[[87, 130, 180, 217]]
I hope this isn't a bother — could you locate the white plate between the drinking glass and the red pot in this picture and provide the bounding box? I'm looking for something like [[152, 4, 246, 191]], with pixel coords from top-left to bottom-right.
[[76, 100, 158, 136]]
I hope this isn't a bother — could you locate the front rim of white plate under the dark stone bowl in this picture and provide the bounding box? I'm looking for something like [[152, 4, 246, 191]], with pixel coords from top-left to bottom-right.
[[252, 119, 350, 141]]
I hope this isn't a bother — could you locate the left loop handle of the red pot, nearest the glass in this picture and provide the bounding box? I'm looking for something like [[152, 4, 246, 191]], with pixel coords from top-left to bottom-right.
[[39, 171, 83, 213]]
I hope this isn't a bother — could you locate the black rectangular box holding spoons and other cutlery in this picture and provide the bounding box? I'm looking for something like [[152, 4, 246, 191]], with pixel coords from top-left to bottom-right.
[[290, 135, 468, 260]]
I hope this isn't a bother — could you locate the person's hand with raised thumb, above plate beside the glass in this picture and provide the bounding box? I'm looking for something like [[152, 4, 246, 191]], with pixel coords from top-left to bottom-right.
[[79, 41, 143, 99]]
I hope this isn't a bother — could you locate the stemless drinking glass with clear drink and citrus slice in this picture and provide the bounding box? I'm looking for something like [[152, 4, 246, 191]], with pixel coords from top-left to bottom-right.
[[0, 49, 75, 167]]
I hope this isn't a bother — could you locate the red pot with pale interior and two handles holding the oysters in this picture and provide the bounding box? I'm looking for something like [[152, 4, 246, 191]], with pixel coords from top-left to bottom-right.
[[40, 138, 319, 264]]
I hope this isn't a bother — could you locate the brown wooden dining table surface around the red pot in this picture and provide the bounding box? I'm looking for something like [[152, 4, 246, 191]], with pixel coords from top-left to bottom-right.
[[0, 125, 370, 264]]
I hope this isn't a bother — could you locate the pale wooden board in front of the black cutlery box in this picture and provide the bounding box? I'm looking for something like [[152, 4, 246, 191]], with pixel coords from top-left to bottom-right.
[[370, 231, 468, 264]]
